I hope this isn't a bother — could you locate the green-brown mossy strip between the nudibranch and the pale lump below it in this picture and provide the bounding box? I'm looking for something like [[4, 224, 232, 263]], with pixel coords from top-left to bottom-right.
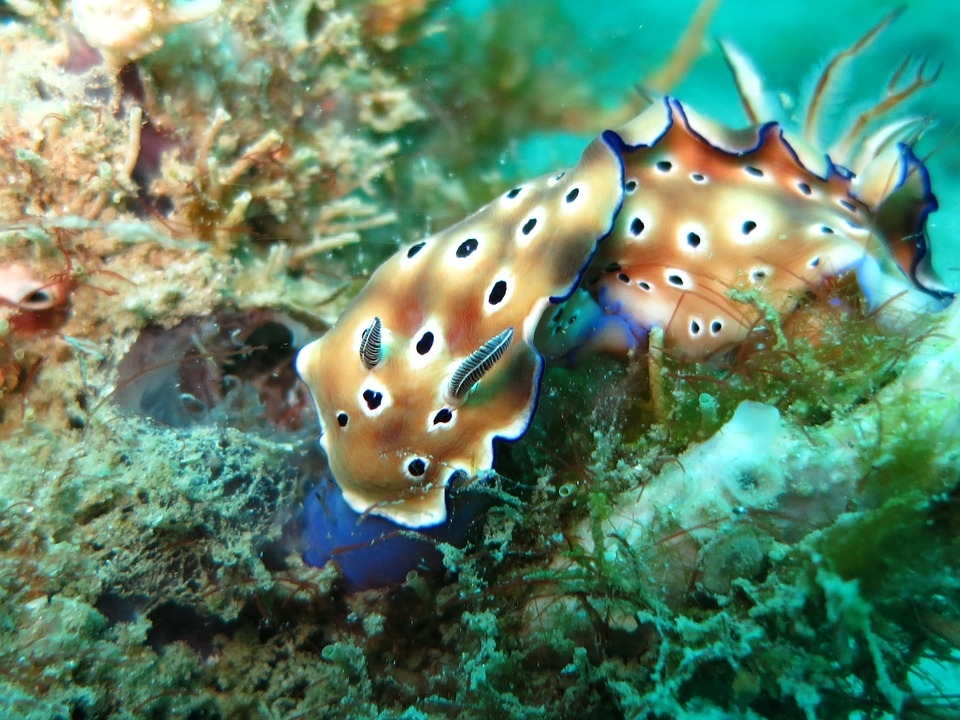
[[497, 287, 937, 527]]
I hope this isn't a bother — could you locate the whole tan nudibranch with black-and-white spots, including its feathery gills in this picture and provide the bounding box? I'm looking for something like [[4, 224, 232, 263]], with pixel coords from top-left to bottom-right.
[[297, 8, 953, 528]]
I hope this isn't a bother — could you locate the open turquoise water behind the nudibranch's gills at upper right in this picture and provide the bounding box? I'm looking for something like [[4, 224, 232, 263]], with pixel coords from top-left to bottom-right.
[[449, 0, 960, 287]]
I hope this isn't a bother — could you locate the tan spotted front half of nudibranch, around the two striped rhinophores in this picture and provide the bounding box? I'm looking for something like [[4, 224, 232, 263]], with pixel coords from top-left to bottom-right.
[[297, 134, 622, 527]]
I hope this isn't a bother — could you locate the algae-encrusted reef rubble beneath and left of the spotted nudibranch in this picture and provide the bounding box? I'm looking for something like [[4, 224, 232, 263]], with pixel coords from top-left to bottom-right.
[[0, 0, 960, 720]]
